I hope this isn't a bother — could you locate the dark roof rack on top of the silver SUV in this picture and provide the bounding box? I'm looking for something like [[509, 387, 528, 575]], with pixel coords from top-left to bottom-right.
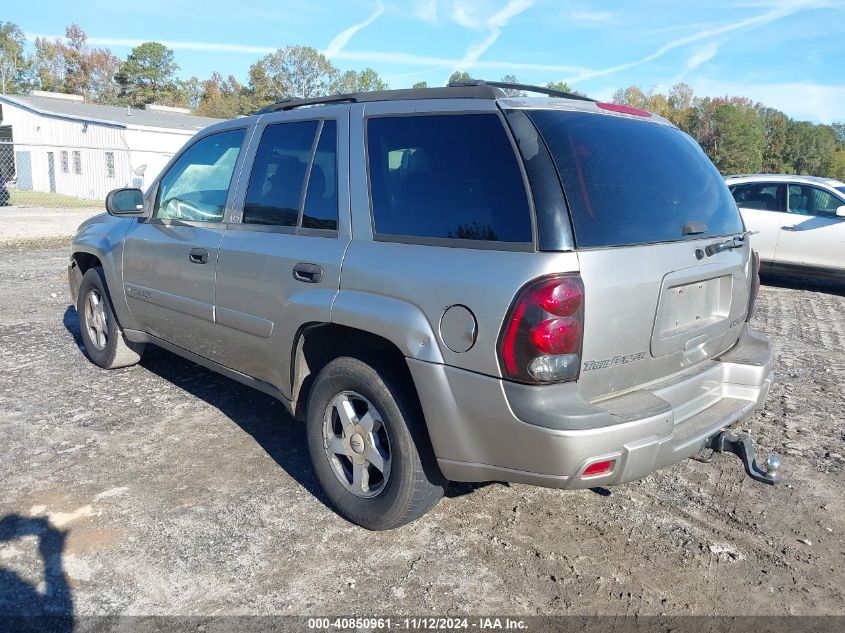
[[256, 79, 595, 114]]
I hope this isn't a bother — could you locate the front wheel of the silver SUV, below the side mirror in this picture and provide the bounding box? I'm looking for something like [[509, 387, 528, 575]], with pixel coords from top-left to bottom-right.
[[76, 266, 144, 369]]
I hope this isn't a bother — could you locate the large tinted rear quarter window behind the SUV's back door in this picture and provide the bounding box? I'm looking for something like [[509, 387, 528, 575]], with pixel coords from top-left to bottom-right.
[[367, 114, 532, 242]]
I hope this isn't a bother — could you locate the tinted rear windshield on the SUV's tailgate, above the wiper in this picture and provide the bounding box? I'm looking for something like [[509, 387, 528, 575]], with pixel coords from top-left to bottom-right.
[[528, 110, 743, 248]]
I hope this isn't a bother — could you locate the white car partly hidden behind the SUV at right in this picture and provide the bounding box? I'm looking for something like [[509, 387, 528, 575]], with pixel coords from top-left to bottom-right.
[[725, 174, 845, 278]]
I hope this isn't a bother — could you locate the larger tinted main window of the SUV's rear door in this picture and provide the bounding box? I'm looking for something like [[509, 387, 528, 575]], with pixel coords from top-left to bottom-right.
[[243, 121, 320, 226]]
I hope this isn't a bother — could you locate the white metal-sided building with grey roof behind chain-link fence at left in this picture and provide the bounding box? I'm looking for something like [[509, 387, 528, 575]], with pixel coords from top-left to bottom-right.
[[0, 91, 218, 199]]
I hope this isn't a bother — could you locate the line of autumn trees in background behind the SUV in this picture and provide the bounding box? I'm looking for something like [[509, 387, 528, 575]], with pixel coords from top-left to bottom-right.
[[0, 22, 845, 180]]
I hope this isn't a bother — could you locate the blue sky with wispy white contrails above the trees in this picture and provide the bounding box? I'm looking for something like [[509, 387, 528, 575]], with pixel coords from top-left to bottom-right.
[[11, 0, 845, 122]]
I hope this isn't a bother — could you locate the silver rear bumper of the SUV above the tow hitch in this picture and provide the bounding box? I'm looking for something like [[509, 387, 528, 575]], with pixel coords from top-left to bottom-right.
[[408, 329, 773, 488]]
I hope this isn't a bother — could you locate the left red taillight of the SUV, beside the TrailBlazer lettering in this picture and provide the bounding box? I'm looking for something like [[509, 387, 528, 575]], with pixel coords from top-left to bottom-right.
[[499, 275, 584, 383]]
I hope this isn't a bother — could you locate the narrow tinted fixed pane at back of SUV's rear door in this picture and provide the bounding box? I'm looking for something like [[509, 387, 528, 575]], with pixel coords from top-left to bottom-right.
[[302, 121, 337, 229]]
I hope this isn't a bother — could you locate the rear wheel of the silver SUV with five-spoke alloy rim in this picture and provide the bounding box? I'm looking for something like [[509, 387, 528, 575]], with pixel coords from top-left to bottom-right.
[[306, 357, 445, 530]]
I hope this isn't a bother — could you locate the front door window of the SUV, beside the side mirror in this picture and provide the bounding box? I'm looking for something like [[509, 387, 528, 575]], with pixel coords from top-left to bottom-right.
[[153, 129, 245, 222]]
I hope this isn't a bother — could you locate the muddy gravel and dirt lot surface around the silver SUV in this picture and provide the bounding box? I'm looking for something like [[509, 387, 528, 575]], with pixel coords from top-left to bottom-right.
[[0, 241, 845, 615]]
